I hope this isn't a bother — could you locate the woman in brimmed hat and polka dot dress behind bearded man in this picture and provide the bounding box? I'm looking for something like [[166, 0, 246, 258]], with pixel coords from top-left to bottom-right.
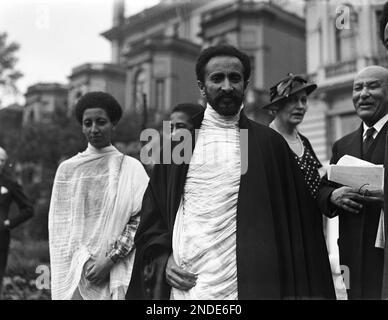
[[264, 73, 322, 198]]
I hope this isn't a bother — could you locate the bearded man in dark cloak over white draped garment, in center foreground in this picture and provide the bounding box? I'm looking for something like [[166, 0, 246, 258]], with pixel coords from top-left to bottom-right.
[[126, 45, 335, 299]]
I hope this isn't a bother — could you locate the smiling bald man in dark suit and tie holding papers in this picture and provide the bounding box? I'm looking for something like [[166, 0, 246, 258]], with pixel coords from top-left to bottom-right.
[[318, 66, 388, 299]]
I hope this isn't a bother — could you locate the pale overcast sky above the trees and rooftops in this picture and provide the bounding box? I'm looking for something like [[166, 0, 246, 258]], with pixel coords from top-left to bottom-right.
[[0, 0, 159, 104]]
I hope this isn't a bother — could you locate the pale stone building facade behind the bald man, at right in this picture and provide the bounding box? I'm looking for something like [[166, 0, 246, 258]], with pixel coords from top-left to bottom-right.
[[300, 0, 388, 162]]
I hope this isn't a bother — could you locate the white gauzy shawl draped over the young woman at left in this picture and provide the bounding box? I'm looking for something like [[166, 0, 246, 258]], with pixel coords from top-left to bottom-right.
[[49, 145, 148, 300]]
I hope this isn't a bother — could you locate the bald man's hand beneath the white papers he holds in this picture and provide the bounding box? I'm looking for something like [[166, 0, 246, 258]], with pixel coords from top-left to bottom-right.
[[330, 187, 364, 213]]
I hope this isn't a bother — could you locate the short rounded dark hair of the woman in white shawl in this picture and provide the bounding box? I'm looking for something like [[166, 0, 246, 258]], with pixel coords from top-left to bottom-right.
[[75, 91, 123, 124]]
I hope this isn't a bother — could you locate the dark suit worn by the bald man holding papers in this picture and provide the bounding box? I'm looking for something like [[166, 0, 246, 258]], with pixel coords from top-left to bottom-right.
[[317, 122, 388, 299]]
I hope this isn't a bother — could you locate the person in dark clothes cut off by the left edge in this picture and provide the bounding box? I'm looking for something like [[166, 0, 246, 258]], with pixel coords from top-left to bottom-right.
[[0, 147, 34, 297]]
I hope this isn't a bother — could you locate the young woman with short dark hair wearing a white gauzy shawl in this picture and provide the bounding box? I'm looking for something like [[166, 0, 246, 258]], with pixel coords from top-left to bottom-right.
[[49, 92, 148, 300]]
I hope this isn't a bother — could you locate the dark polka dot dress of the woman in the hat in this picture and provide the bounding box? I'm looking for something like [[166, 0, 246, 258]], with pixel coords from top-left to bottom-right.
[[295, 139, 322, 198]]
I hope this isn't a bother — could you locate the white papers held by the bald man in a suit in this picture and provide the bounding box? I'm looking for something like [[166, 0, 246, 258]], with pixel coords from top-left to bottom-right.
[[327, 155, 384, 193]]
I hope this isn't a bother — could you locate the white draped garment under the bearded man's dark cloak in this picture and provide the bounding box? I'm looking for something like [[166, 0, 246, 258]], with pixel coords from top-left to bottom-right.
[[170, 105, 241, 300]]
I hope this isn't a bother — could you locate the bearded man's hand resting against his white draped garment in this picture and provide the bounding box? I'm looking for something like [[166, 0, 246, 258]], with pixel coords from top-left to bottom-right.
[[166, 254, 197, 291]]
